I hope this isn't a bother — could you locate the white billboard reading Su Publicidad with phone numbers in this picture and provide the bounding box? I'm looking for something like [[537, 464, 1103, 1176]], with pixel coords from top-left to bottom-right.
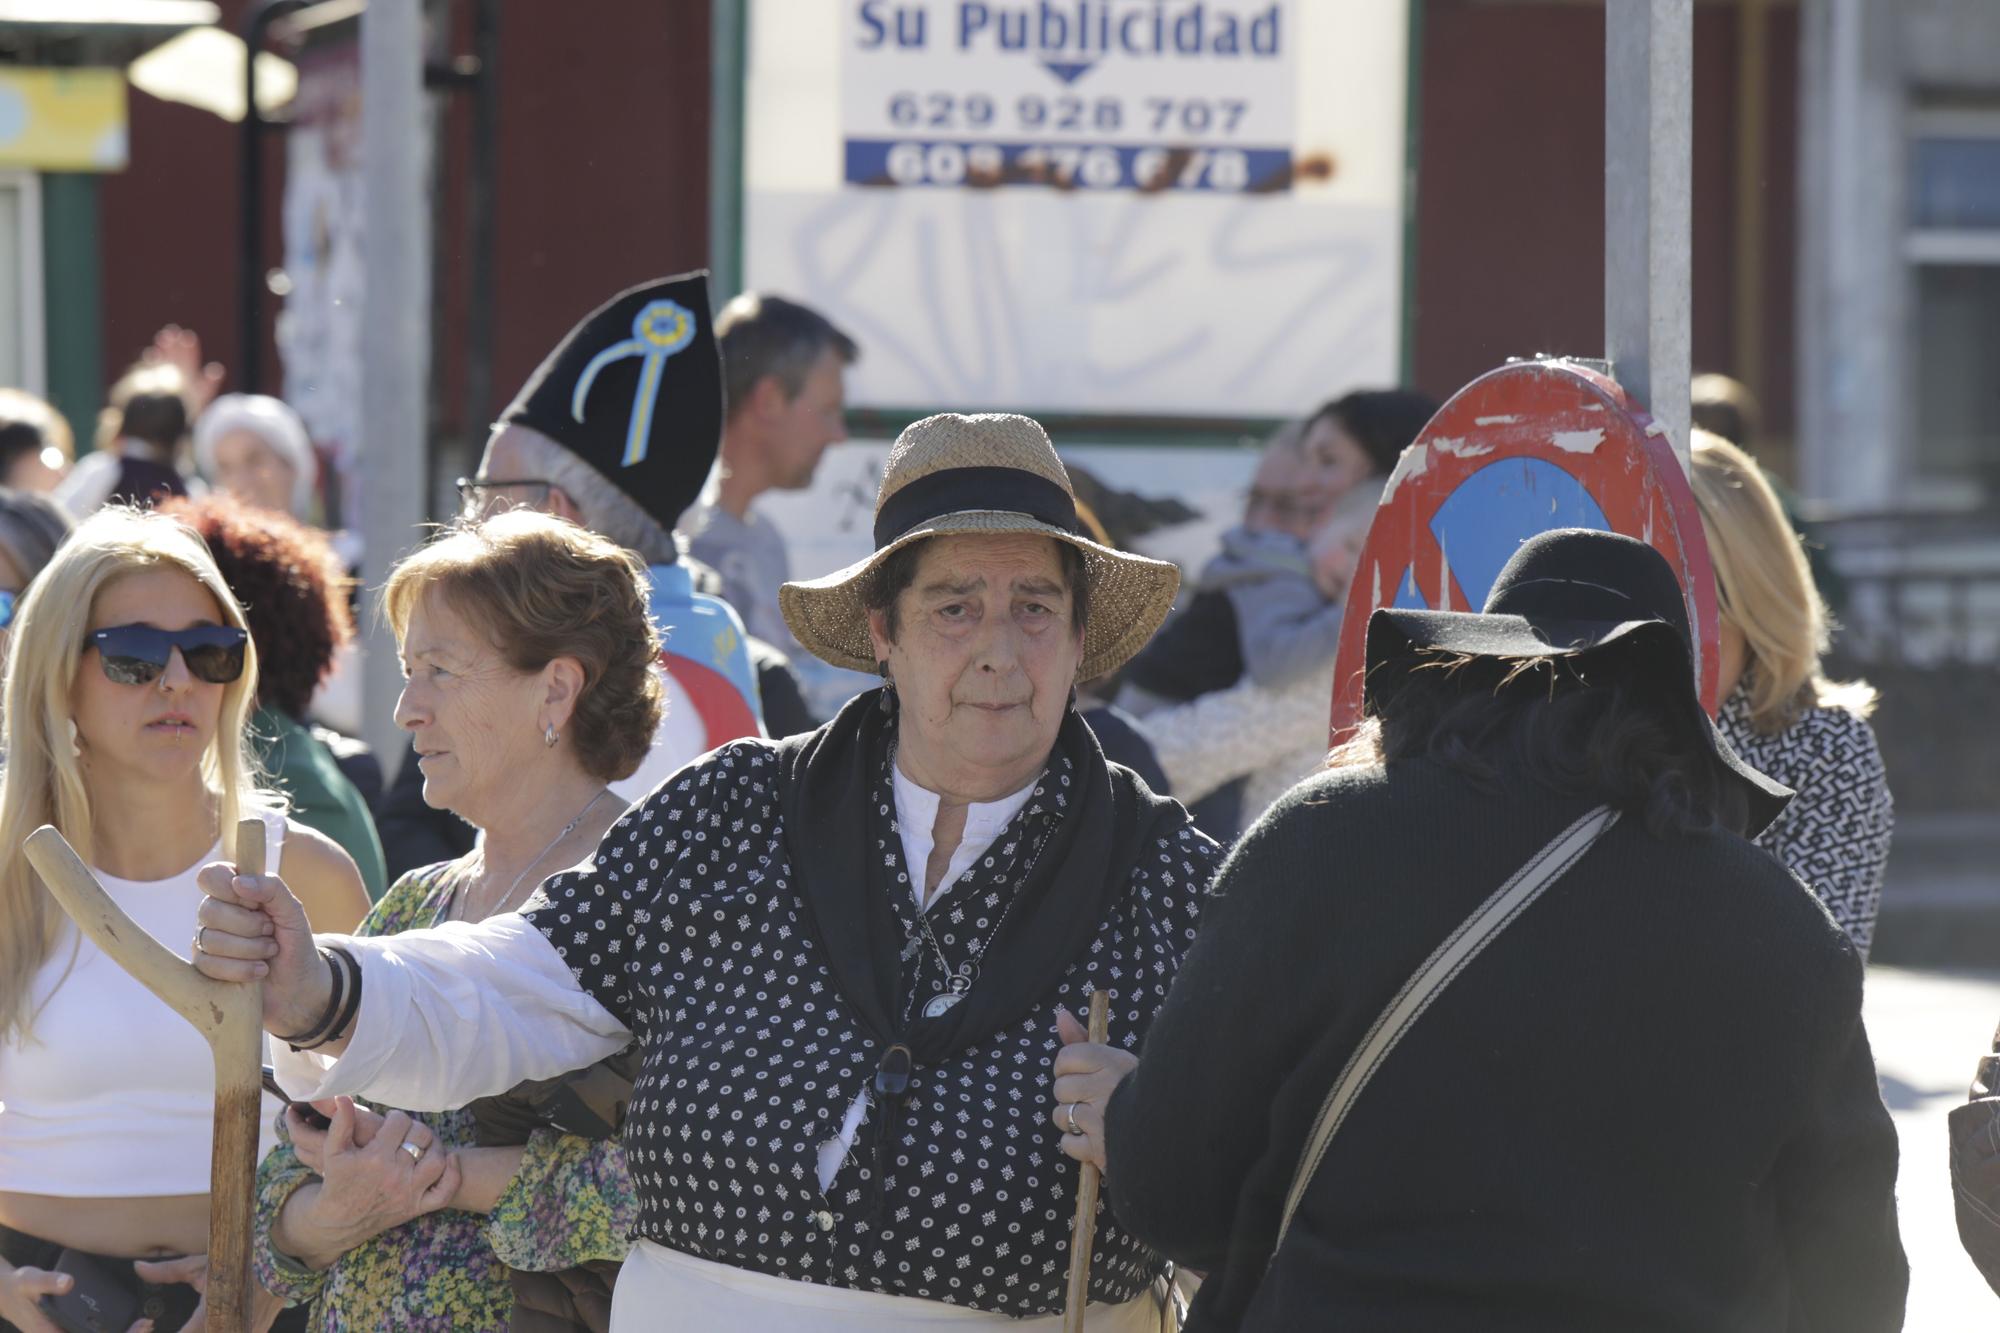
[[742, 0, 1408, 420]]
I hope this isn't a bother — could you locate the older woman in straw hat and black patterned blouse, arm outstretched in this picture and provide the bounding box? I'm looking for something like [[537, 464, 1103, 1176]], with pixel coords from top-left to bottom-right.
[[191, 416, 1218, 1331]]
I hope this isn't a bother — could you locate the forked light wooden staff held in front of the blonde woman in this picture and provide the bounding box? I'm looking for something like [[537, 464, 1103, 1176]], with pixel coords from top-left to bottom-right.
[[24, 819, 264, 1333]]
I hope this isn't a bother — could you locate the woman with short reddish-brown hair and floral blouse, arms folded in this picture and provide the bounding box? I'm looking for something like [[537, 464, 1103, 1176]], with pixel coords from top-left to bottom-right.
[[256, 510, 660, 1333]]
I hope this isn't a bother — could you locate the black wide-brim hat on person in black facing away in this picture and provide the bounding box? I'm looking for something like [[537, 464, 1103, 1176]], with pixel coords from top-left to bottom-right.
[[1362, 528, 1792, 839]]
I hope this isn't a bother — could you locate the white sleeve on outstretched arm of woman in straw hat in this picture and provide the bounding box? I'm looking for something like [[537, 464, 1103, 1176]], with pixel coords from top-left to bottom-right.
[[272, 913, 632, 1111]]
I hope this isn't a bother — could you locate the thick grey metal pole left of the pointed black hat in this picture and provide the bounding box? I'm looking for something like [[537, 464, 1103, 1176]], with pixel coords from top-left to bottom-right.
[[360, 0, 430, 779]]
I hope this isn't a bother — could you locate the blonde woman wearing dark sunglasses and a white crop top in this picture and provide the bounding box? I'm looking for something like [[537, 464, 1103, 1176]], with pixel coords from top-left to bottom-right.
[[0, 510, 368, 1333]]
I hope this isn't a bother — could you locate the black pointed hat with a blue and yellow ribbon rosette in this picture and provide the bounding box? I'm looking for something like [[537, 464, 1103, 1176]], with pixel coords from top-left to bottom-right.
[[500, 270, 722, 528]]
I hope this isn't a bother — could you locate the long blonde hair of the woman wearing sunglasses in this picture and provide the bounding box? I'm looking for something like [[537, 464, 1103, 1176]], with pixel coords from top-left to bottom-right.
[[0, 508, 272, 1041]]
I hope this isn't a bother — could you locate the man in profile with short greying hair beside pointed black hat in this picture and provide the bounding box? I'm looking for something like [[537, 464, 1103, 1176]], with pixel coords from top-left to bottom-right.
[[682, 292, 866, 676]]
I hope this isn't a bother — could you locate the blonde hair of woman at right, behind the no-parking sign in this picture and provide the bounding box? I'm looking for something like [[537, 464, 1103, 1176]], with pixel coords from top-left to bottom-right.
[[1688, 430, 1876, 735]]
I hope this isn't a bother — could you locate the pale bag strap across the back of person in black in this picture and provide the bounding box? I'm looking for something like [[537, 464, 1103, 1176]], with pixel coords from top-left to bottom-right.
[[1272, 805, 1618, 1257]]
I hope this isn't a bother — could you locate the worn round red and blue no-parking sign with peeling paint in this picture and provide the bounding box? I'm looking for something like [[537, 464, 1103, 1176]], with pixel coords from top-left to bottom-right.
[[1332, 360, 1718, 745]]
